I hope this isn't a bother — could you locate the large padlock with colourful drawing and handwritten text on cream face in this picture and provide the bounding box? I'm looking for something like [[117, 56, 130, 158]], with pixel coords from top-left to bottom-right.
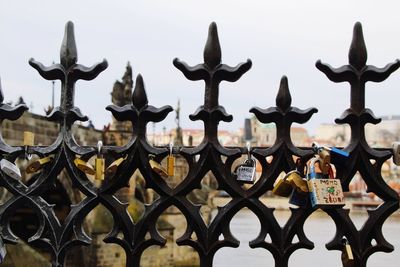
[[307, 157, 345, 208]]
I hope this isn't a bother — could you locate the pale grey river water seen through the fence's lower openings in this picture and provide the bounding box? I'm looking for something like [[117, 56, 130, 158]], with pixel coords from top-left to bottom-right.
[[214, 209, 400, 267]]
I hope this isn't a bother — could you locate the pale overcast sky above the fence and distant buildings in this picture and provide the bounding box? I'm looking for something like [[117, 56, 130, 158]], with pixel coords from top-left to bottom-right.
[[0, 0, 400, 134]]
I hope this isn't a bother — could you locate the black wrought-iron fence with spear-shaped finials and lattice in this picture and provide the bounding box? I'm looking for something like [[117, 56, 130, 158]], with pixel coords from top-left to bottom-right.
[[0, 22, 400, 267]]
